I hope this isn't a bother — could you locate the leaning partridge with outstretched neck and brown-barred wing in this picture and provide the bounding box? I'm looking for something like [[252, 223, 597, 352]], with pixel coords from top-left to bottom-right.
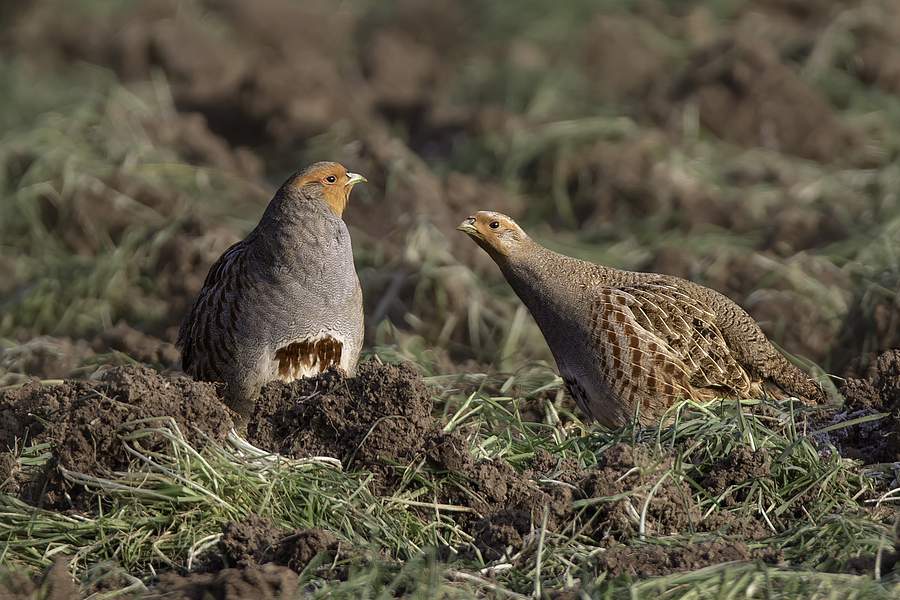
[[458, 211, 825, 426]]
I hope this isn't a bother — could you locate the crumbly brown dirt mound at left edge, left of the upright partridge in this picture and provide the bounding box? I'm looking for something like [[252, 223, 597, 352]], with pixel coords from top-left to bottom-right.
[[0, 366, 232, 505]]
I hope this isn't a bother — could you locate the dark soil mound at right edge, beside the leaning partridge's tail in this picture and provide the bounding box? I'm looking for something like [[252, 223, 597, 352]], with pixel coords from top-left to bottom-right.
[[823, 350, 900, 464]]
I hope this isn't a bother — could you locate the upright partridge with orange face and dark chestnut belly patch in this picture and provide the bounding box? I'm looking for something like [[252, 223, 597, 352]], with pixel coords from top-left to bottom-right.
[[178, 162, 366, 420]]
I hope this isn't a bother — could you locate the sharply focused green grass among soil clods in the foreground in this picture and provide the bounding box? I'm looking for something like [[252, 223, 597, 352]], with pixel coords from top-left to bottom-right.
[[0, 376, 900, 598]]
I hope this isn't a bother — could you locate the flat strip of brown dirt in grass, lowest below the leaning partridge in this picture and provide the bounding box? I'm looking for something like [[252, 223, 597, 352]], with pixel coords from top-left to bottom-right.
[[597, 540, 756, 578]]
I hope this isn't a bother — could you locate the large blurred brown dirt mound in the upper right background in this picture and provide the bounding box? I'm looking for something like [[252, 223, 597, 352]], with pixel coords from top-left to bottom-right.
[[667, 40, 860, 162]]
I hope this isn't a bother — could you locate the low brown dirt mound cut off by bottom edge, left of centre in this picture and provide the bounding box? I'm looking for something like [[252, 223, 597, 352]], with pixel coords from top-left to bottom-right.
[[145, 564, 300, 600]]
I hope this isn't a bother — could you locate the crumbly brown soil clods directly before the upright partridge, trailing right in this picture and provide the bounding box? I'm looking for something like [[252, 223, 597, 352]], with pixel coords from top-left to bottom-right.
[[248, 362, 572, 558]]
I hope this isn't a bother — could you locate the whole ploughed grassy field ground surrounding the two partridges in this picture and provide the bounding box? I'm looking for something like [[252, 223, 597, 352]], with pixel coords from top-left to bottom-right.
[[0, 0, 900, 599]]
